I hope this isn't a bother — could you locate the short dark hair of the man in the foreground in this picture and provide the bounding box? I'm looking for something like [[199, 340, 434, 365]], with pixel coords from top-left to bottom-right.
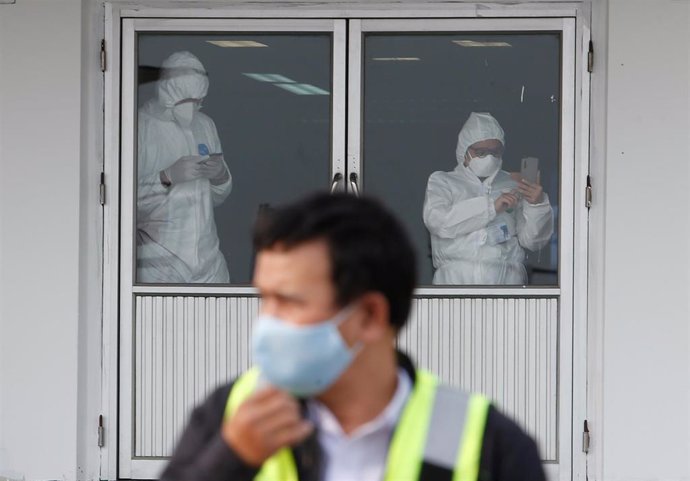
[[254, 193, 416, 330]]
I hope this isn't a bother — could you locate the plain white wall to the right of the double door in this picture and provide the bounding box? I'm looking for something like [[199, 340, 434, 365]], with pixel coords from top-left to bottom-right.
[[593, 0, 690, 481]]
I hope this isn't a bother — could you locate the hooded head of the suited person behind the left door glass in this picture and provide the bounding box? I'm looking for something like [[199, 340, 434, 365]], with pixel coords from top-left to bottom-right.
[[158, 51, 208, 109]]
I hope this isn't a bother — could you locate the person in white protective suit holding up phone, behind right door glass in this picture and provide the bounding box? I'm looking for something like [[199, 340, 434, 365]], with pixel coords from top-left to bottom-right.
[[423, 112, 553, 285]]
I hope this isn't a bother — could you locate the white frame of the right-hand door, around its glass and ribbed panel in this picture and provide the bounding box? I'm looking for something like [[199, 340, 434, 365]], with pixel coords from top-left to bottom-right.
[[347, 17, 584, 480]]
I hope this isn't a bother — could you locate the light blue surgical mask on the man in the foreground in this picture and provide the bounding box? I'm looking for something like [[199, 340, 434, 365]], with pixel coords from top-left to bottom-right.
[[253, 309, 361, 397]]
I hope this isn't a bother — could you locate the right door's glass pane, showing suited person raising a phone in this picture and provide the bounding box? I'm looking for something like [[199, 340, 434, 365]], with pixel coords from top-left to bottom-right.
[[362, 32, 561, 285]]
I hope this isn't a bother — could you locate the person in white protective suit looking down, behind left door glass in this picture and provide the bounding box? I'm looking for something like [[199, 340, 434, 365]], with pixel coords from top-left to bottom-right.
[[137, 52, 232, 283]]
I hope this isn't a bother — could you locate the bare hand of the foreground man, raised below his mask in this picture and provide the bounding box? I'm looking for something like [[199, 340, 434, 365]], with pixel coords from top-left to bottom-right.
[[222, 386, 314, 467]]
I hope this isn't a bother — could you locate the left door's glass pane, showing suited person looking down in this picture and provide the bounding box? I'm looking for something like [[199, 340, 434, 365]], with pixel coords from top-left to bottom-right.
[[136, 33, 332, 284]]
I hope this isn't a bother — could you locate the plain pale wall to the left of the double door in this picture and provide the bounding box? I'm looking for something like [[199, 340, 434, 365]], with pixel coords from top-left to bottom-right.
[[0, 0, 82, 480]]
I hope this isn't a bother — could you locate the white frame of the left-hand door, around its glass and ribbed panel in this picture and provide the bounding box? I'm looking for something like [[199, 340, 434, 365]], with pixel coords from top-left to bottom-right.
[[110, 14, 346, 478]]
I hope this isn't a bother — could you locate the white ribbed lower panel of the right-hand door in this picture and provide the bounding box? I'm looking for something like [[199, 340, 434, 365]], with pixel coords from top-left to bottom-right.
[[399, 298, 559, 462]]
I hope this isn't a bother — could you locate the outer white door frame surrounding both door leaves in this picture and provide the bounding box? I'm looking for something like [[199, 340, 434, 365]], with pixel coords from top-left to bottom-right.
[[99, 1, 591, 479]]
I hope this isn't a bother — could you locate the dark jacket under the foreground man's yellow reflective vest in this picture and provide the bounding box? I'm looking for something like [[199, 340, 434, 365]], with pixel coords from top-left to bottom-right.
[[161, 354, 546, 481]]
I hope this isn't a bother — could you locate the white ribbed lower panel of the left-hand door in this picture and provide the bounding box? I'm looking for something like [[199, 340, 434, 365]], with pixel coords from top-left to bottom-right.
[[133, 296, 259, 458]]
